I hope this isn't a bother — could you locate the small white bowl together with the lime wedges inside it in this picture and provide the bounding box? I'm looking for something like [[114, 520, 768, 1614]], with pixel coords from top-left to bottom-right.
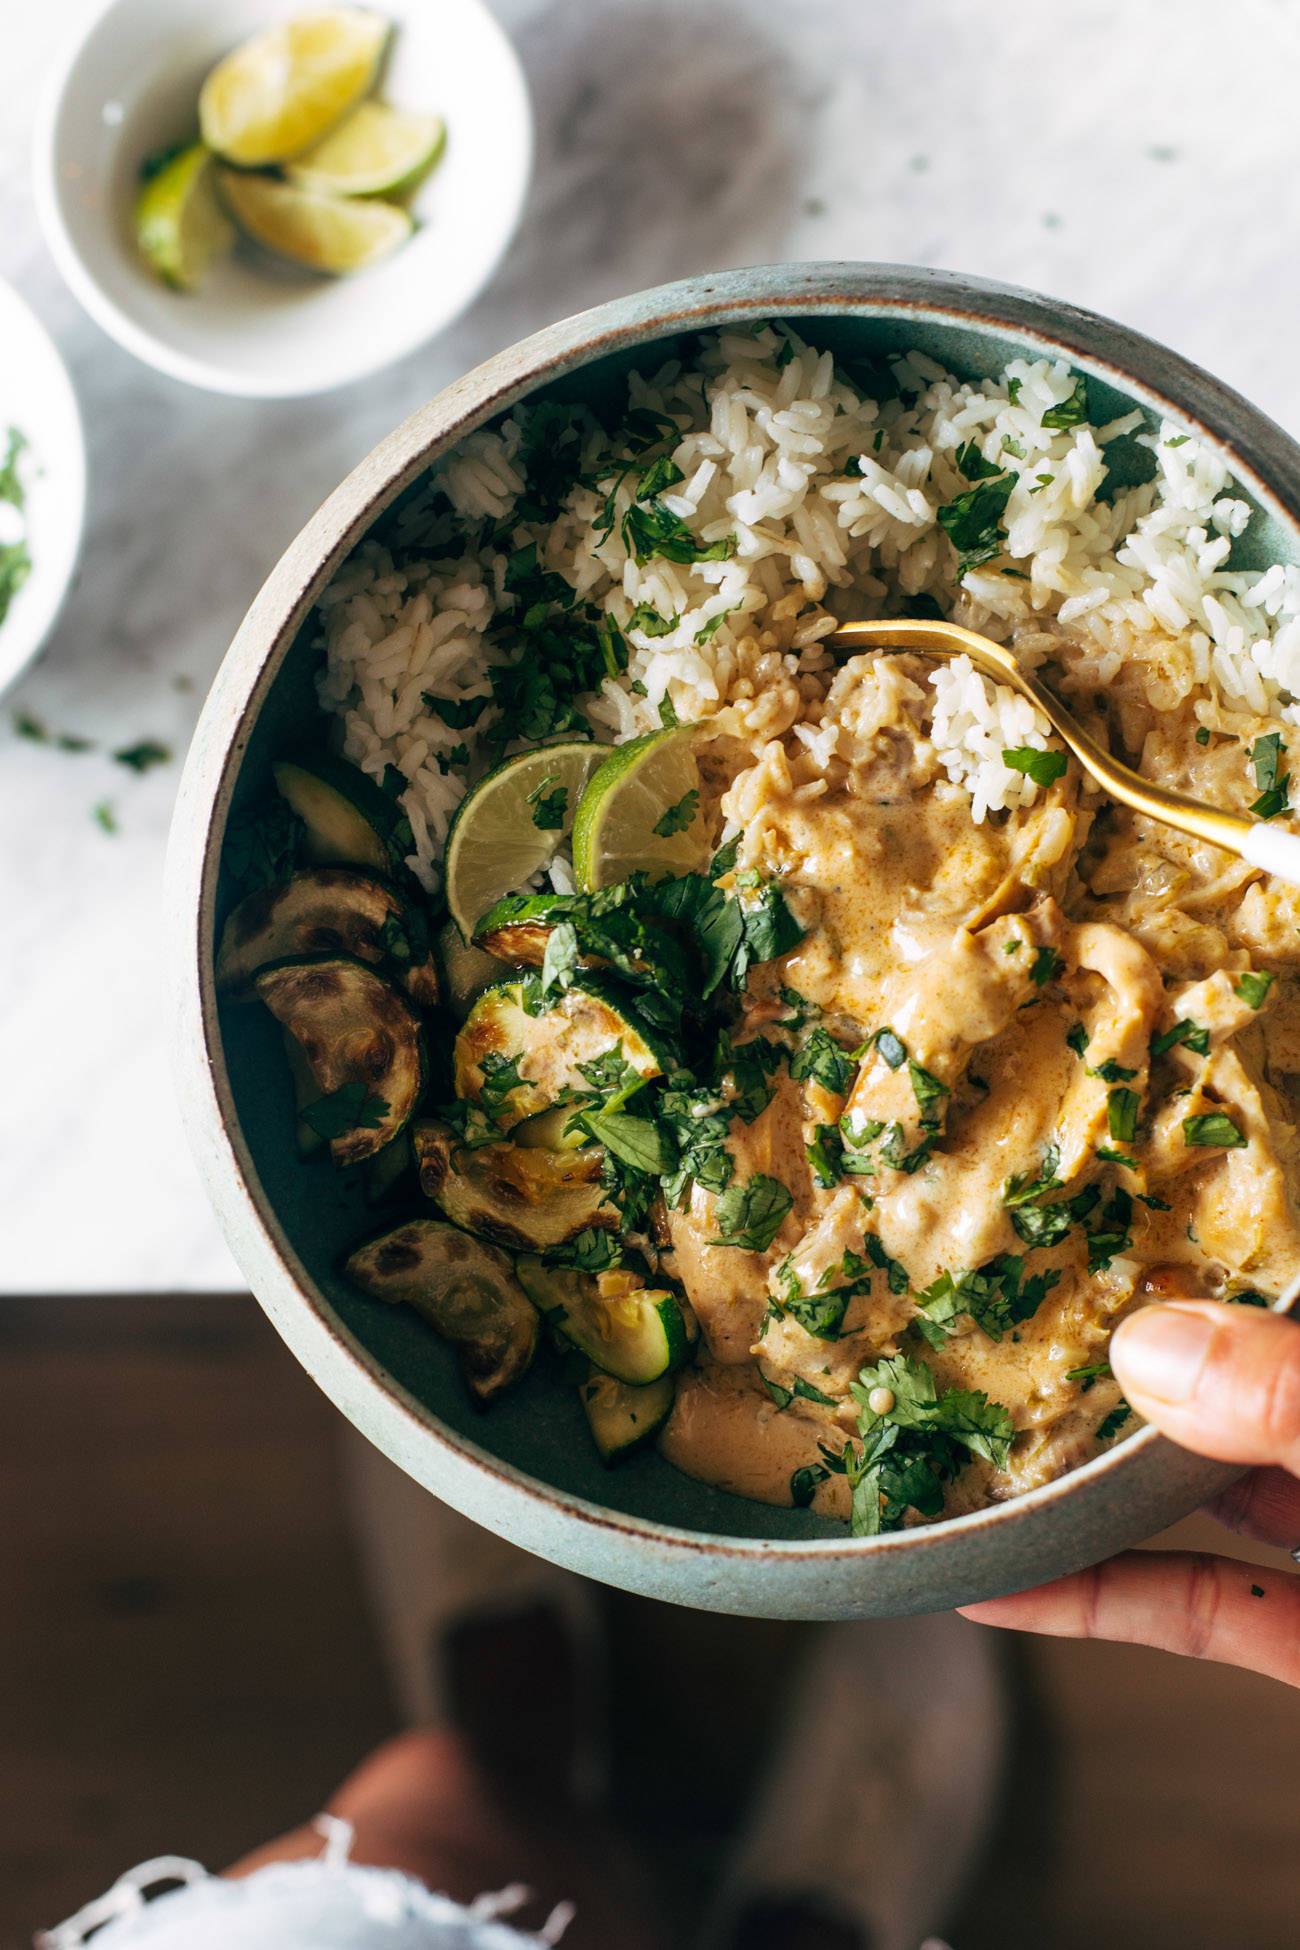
[[33, 0, 532, 400]]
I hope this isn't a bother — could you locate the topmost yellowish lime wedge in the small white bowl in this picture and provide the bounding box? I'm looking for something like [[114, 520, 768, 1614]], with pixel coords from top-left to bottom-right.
[[199, 6, 388, 170]]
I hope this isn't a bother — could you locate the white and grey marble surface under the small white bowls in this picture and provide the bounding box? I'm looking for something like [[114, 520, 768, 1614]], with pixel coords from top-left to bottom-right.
[[0, 0, 1300, 1293]]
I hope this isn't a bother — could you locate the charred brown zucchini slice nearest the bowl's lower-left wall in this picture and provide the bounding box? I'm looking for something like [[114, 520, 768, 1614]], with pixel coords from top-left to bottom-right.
[[343, 1219, 538, 1402]]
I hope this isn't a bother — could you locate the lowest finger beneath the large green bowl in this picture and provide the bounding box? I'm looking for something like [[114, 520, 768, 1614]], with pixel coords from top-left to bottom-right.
[[961, 1550, 1300, 1687]]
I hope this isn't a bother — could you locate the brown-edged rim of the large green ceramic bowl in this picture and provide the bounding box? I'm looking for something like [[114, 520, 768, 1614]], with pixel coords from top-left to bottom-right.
[[166, 261, 1300, 1615]]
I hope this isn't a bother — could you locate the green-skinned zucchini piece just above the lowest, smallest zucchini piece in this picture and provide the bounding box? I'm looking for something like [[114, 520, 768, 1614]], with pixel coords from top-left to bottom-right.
[[515, 1256, 694, 1388]]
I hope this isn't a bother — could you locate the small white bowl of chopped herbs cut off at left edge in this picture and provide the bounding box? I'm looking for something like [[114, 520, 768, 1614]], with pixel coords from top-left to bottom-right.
[[0, 283, 86, 690]]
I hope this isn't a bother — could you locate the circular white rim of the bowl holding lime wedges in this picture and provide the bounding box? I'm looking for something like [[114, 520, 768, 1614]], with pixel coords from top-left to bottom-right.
[[31, 0, 536, 400]]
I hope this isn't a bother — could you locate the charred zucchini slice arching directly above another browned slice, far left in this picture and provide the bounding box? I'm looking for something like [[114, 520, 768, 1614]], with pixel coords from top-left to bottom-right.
[[216, 866, 439, 1008]]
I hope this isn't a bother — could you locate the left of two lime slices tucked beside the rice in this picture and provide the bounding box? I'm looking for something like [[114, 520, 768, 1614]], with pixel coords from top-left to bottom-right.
[[444, 741, 608, 940]]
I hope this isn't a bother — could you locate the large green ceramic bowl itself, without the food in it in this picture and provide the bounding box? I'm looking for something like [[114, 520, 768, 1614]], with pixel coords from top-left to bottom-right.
[[170, 263, 1300, 1619]]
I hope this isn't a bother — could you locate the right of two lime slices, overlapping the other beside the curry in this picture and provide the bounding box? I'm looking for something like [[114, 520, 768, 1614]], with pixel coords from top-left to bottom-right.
[[573, 725, 709, 891]]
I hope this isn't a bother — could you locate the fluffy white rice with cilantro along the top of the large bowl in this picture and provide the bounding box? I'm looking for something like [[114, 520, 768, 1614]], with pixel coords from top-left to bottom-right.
[[311, 326, 1300, 887]]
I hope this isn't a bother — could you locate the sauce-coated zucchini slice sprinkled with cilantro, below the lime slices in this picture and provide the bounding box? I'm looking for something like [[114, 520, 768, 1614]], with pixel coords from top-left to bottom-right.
[[452, 975, 672, 1131]]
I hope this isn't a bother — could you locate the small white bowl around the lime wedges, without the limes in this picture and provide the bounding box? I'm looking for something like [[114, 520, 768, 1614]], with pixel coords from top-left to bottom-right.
[[33, 0, 532, 400]]
